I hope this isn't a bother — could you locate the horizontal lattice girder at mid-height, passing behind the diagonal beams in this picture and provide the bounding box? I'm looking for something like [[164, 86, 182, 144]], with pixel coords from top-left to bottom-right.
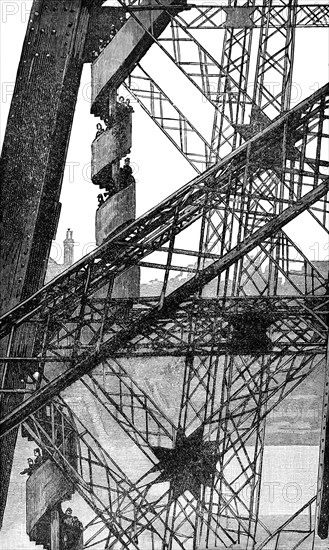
[[0, 295, 329, 364]]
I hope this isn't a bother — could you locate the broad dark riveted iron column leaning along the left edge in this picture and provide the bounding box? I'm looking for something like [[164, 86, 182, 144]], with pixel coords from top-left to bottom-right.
[[0, 0, 90, 523]]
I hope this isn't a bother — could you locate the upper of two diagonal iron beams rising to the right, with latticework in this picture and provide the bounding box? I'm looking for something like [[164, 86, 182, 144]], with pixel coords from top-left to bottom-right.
[[0, 84, 329, 337]]
